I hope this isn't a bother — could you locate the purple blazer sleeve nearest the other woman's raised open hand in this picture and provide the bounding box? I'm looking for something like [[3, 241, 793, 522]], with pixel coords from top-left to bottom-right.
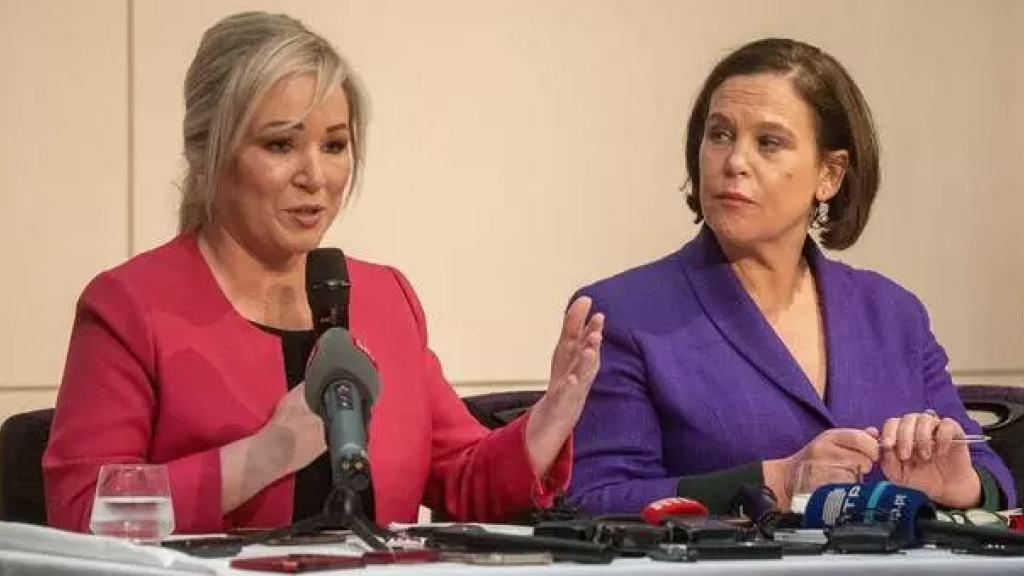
[[569, 296, 680, 513]]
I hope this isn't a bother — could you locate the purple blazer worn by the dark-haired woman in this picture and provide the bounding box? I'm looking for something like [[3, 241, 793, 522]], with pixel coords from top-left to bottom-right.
[[569, 227, 1015, 513]]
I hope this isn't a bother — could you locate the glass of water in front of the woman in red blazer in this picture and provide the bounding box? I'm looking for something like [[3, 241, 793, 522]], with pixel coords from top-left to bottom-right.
[[89, 464, 174, 543]]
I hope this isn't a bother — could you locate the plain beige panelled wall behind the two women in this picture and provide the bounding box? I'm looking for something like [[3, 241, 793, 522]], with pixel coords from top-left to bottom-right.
[[0, 0, 1024, 426]]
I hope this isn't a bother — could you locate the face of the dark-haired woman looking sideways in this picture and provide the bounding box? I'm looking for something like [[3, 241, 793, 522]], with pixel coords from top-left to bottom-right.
[[699, 74, 844, 248]]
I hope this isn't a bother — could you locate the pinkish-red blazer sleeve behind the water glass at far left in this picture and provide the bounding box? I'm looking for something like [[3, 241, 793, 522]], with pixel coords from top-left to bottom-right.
[[43, 273, 223, 532]]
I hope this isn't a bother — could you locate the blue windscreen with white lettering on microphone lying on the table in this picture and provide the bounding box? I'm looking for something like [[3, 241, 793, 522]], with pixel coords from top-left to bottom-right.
[[803, 481, 935, 543]]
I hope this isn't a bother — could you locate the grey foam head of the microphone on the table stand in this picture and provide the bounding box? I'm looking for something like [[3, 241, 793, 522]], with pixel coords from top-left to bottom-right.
[[305, 328, 381, 414]]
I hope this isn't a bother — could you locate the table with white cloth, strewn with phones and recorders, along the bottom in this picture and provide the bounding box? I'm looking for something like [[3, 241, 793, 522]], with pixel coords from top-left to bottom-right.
[[0, 523, 1024, 576]]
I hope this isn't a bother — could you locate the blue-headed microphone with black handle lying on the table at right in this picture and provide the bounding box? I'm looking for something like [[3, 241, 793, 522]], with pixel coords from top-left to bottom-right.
[[803, 481, 1024, 546]]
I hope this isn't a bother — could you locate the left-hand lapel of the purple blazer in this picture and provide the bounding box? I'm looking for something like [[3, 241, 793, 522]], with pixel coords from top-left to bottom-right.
[[682, 225, 833, 426]]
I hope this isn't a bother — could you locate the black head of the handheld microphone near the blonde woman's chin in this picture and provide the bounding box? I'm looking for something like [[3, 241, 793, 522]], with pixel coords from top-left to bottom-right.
[[306, 248, 349, 335]]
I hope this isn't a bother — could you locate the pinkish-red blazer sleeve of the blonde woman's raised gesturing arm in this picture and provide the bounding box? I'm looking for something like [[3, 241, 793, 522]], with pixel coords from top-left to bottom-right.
[[391, 269, 572, 523]]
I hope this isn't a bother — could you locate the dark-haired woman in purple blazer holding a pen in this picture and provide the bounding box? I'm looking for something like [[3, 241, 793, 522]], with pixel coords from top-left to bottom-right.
[[570, 39, 1015, 513]]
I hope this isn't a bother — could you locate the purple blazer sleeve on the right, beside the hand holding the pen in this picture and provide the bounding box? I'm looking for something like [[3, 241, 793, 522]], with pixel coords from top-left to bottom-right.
[[913, 297, 1017, 508]]
